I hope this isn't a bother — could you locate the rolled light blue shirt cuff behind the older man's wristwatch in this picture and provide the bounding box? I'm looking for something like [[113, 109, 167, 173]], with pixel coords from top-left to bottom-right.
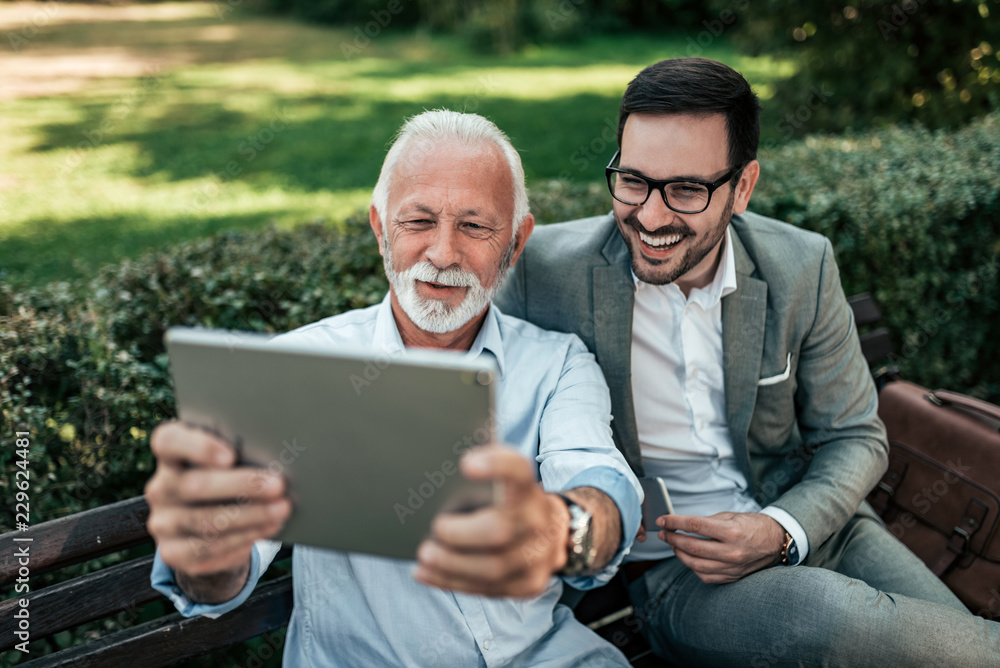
[[556, 466, 642, 591]]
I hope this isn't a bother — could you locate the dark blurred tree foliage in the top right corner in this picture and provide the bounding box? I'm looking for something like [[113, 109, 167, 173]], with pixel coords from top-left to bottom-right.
[[713, 0, 1000, 137]]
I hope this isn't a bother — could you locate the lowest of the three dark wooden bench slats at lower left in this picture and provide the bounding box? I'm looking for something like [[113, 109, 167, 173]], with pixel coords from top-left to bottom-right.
[[30, 575, 292, 668]]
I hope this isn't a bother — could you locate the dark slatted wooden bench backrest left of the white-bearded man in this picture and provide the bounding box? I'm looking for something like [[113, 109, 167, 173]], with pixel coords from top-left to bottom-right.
[[0, 497, 292, 668]]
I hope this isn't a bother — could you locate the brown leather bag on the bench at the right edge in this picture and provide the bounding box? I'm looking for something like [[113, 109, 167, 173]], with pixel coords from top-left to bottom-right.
[[868, 380, 1000, 619]]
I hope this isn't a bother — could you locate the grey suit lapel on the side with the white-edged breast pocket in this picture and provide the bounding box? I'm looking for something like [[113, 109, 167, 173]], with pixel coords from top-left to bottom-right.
[[722, 228, 767, 484]]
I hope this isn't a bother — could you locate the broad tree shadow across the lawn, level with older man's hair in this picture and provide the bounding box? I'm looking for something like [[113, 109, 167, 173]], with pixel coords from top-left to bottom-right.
[[34, 93, 618, 191]]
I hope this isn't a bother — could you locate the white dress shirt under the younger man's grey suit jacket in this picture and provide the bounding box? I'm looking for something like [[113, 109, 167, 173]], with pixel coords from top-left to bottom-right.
[[629, 227, 809, 563]]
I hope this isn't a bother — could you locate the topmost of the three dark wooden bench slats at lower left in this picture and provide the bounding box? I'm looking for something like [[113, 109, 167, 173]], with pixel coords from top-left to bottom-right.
[[0, 496, 150, 586]]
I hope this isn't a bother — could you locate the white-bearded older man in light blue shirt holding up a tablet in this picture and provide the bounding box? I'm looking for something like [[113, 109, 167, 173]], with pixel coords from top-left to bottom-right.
[[146, 110, 641, 668]]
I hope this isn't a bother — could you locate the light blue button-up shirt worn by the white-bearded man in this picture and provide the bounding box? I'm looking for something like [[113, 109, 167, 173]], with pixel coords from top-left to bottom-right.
[[151, 296, 642, 668]]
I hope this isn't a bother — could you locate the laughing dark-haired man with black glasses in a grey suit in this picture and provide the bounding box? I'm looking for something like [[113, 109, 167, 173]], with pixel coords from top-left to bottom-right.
[[496, 58, 1000, 667]]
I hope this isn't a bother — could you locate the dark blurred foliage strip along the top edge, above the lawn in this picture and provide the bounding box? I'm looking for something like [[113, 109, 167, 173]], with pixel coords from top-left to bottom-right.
[[266, 0, 706, 53]]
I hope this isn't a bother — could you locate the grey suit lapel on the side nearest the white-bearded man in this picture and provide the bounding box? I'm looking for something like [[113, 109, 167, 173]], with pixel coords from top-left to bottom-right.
[[591, 226, 642, 476]]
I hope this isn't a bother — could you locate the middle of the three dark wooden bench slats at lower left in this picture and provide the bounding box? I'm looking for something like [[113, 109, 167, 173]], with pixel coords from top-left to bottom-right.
[[0, 555, 163, 650]]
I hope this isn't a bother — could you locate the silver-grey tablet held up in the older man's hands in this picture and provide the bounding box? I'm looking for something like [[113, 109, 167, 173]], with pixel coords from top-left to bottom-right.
[[165, 328, 497, 559]]
